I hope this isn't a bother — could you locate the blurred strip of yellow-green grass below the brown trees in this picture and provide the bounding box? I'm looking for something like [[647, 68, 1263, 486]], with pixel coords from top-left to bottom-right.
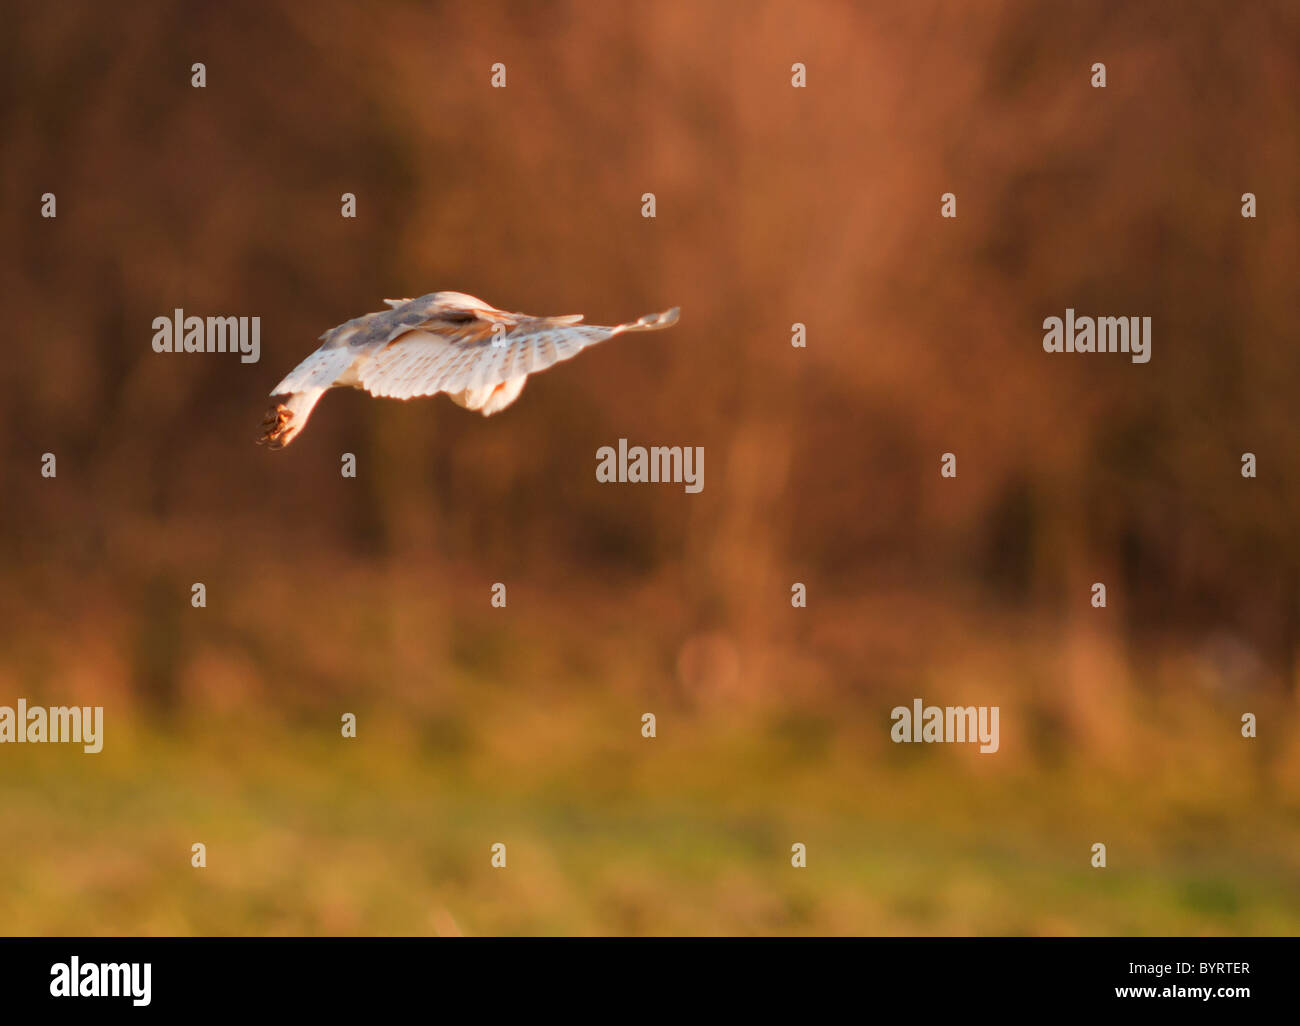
[[0, 696, 1300, 935]]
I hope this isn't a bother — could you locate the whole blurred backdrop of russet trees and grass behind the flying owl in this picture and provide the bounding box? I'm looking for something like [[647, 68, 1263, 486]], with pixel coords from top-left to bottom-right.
[[0, 0, 1300, 935]]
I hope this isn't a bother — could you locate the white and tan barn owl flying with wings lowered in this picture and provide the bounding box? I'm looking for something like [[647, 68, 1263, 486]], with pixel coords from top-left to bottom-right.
[[259, 293, 680, 449]]
